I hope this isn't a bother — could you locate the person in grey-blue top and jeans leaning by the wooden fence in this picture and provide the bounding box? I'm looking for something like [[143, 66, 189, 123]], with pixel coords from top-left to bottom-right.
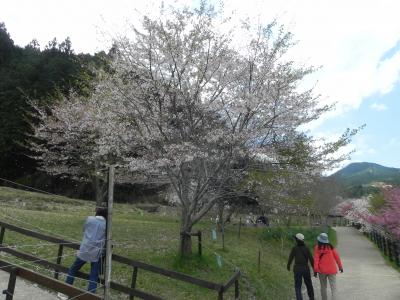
[[65, 208, 107, 293]]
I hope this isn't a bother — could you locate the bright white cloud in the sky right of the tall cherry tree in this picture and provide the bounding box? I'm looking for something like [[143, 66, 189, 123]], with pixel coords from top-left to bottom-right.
[[220, 0, 400, 119]]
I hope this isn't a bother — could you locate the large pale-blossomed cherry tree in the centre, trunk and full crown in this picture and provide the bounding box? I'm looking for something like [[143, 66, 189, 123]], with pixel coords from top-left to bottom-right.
[[38, 6, 354, 255]]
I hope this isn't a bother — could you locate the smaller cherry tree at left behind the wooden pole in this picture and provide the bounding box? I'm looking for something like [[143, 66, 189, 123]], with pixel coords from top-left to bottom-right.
[[31, 95, 111, 205]]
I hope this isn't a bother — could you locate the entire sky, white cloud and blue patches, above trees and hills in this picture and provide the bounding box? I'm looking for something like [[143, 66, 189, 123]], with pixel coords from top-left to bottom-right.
[[0, 0, 400, 171]]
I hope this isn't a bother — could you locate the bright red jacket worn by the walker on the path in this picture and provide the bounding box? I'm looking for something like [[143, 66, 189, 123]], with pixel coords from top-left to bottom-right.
[[314, 245, 343, 274]]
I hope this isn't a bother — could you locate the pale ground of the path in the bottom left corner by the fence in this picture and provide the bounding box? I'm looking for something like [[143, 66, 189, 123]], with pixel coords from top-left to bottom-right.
[[0, 271, 60, 300]]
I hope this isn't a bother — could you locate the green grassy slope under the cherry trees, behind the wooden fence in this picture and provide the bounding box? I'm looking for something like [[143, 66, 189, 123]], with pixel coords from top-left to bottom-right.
[[0, 187, 328, 300]]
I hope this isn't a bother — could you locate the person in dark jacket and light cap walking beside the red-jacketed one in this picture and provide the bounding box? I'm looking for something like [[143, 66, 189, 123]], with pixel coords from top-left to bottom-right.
[[287, 233, 314, 300]]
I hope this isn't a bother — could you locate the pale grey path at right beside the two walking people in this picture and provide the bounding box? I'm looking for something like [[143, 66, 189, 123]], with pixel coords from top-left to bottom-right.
[[312, 227, 400, 300]]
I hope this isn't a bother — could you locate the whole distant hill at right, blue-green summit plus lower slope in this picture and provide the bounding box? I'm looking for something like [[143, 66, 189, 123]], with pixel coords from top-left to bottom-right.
[[330, 162, 400, 198]]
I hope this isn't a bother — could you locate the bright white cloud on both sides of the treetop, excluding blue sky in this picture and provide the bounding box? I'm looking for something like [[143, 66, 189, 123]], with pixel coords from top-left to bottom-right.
[[1, 0, 400, 122]]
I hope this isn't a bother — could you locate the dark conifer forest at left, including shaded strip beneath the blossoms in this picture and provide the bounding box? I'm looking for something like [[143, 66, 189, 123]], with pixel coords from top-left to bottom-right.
[[0, 22, 166, 202]]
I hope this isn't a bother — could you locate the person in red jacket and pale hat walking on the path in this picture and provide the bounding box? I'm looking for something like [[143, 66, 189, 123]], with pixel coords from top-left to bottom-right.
[[314, 233, 343, 300]]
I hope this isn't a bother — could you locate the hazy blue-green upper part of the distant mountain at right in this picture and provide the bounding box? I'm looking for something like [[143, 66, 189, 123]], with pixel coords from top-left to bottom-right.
[[331, 162, 400, 187]]
